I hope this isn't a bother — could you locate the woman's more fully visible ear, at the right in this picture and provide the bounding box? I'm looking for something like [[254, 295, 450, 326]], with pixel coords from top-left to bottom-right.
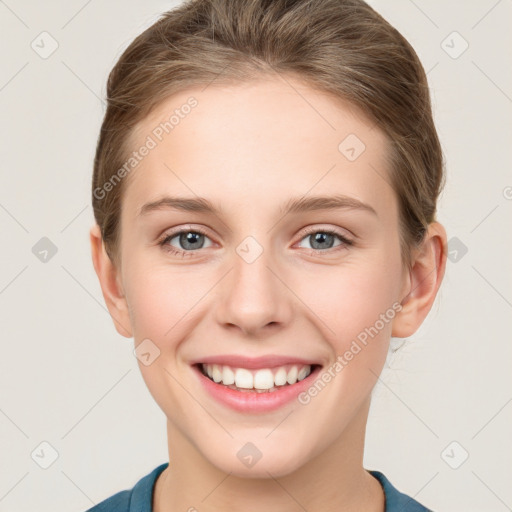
[[391, 222, 447, 338]]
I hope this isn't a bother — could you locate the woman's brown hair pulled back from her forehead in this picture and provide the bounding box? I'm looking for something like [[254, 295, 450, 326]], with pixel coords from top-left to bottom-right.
[[92, 0, 444, 265]]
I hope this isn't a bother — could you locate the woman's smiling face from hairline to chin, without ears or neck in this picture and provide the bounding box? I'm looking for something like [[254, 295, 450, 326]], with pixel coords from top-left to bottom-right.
[[115, 78, 407, 477]]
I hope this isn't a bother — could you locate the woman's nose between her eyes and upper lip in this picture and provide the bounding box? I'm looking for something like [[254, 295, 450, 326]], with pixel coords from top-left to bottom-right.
[[216, 242, 293, 338]]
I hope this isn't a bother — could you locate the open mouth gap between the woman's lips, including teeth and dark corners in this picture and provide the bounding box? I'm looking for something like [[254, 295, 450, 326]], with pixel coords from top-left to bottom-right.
[[194, 363, 320, 393]]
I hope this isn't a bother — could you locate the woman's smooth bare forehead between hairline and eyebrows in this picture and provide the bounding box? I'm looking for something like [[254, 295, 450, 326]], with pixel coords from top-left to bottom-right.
[[123, 77, 396, 215]]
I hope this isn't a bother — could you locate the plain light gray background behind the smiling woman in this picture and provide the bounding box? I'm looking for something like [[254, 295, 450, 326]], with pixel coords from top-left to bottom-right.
[[0, 0, 512, 512]]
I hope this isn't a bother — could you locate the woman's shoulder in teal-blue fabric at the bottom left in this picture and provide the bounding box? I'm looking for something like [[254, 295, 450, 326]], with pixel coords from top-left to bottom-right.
[[86, 462, 169, 512]]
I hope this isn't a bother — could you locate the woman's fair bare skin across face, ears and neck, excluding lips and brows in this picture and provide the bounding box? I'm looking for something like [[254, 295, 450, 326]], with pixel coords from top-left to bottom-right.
[[90, 73, 446, 512]]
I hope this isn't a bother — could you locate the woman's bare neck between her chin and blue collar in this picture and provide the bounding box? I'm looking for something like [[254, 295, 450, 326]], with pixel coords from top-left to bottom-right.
[[153, 398, 385, 512]]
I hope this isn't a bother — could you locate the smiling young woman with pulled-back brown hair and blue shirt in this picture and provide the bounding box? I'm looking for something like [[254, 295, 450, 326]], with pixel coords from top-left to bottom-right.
[[90, 0, 446, 512]]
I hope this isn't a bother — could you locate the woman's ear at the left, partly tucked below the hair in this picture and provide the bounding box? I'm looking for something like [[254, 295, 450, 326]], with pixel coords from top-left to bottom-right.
[[89, 224, 133, 338]]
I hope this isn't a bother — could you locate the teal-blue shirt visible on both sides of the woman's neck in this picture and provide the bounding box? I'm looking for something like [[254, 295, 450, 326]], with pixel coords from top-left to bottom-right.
[[86, 462, 432, 512]]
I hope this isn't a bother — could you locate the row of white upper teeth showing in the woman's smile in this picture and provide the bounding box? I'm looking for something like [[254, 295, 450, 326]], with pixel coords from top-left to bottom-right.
[[202, 364, 311, 389]]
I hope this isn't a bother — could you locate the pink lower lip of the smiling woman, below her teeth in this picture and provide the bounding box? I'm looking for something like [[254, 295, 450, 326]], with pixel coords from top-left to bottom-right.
[[193, 365, 321, 413]]
